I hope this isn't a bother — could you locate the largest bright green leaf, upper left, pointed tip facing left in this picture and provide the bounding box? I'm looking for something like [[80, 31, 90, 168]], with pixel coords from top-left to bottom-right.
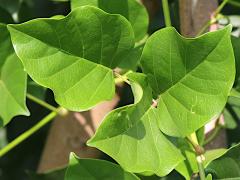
[[8, 6, 134, 111]]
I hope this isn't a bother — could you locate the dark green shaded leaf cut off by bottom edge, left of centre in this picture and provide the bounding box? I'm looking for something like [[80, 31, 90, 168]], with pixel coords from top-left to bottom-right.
[[65, 154, 140, 180]]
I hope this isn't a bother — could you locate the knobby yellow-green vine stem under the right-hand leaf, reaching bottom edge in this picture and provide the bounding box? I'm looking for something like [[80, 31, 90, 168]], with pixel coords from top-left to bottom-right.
[[188, 133, 206, 180]]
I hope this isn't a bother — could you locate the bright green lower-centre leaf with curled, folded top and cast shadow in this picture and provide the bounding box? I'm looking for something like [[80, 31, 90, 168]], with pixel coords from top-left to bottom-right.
[[88, 73, 183, 176]]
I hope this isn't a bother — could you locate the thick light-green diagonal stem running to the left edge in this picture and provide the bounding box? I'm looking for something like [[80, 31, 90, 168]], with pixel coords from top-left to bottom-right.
[[0, 108, 61, 157]]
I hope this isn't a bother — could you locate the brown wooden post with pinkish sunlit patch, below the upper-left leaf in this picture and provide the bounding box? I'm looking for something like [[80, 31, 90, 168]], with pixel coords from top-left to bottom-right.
[[38, 88, 120, 173]]
